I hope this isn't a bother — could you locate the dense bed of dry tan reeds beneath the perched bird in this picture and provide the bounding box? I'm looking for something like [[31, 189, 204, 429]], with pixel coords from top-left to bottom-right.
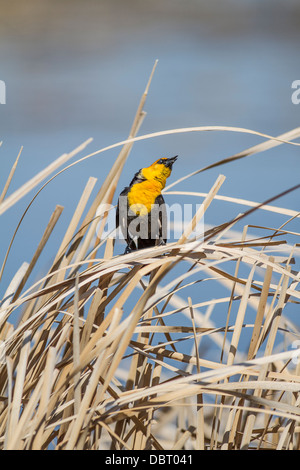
[[0, 62, 300, 450]]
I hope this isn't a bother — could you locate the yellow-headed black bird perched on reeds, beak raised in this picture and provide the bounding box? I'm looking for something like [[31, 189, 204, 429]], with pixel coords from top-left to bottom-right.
[[116, 156, 177, 253]]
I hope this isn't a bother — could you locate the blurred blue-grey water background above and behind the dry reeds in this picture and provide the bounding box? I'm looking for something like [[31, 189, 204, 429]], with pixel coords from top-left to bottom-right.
[[0, 0, 300, 312]]
